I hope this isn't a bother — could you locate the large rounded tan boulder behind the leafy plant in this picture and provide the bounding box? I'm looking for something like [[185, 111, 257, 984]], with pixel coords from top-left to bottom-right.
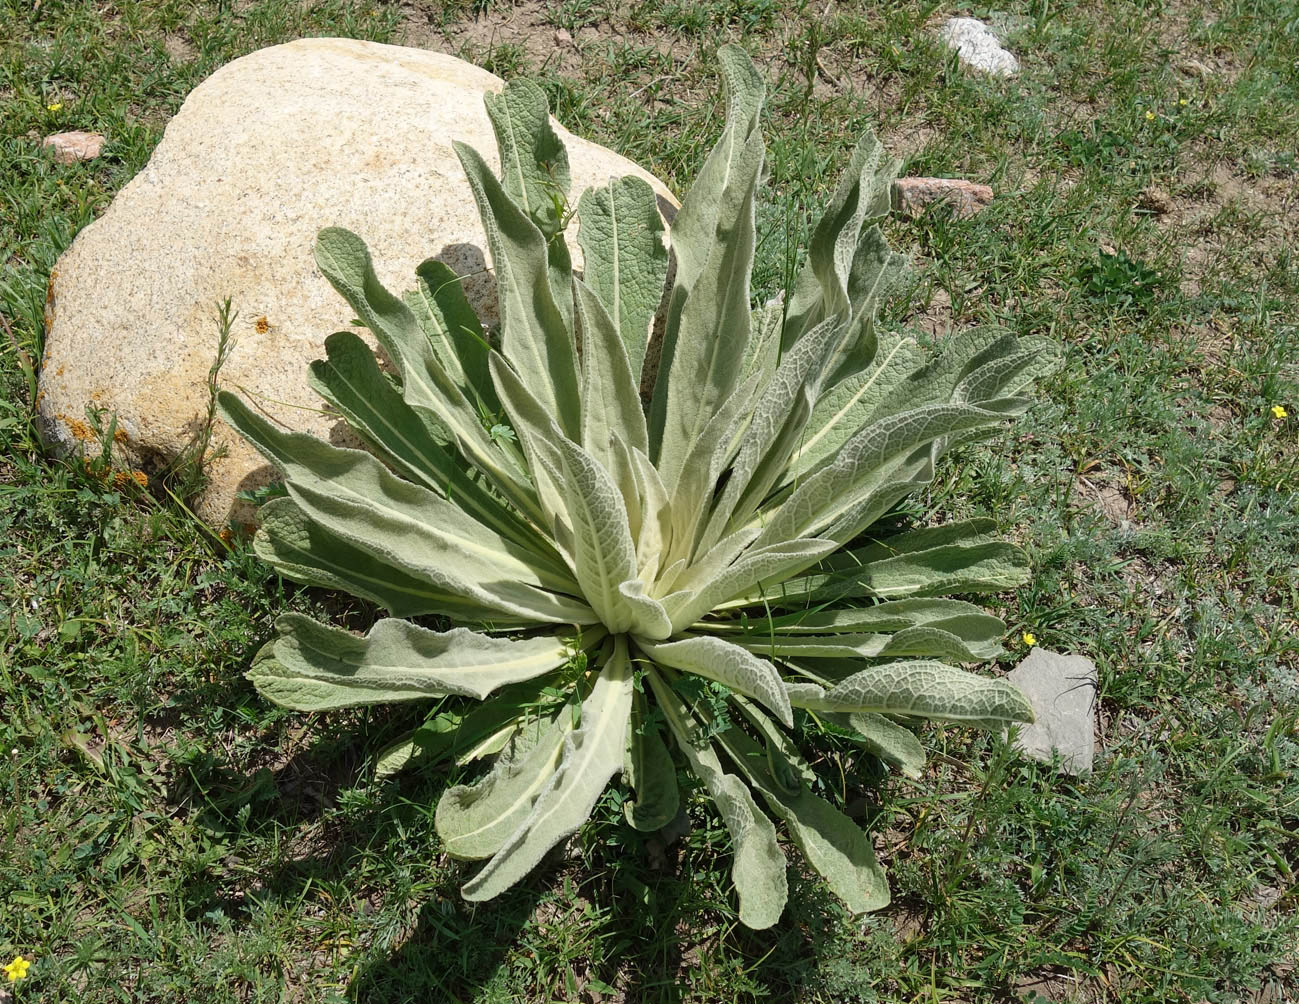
[[40, 39, 675, 527]]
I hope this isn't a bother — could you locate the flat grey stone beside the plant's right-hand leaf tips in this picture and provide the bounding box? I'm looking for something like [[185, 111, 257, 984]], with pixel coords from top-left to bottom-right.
[[1007, 648, 1096, 774]]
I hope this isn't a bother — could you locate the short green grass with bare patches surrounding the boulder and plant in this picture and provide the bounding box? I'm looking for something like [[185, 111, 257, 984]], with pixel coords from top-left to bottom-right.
[[0, 0, 1299, 1004]]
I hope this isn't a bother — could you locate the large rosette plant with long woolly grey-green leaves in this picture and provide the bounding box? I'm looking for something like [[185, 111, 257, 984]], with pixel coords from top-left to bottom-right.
[[220, 47, 1056, 929]]
